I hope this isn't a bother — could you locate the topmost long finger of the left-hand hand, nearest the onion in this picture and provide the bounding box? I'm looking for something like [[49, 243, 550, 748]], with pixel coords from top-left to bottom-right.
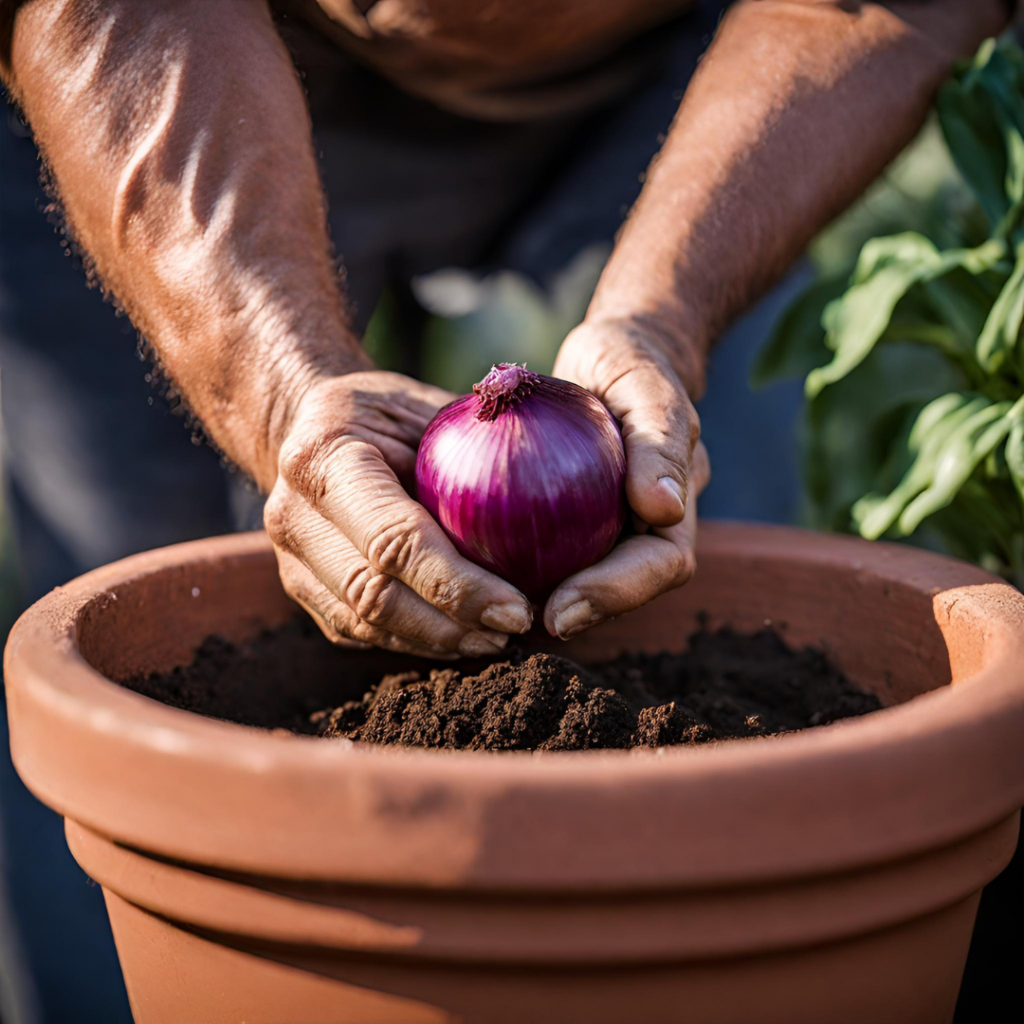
[[282, 436, 532, 633]]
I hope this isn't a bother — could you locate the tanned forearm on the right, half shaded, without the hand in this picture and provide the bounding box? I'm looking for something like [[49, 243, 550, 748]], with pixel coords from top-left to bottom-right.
[[588, 0, 1007, 396]]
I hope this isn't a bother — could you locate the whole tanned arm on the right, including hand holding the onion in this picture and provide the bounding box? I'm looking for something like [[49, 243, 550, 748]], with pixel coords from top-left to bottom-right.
[[545, 0, 1010, 636]]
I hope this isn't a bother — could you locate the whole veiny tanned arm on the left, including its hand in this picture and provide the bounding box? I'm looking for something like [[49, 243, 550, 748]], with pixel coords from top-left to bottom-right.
[[0, 0, 531, 656]]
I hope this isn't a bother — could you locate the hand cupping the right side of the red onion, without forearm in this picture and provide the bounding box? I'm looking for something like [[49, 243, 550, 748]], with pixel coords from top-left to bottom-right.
[[544, 321, 711, 640]]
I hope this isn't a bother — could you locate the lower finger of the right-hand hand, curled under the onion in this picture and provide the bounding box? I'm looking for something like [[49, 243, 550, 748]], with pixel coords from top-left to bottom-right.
[[544, 493, 697, 640]]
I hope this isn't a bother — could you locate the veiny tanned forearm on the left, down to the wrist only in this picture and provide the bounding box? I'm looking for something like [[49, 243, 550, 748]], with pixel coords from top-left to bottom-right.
[[2, 0, 369, 487]]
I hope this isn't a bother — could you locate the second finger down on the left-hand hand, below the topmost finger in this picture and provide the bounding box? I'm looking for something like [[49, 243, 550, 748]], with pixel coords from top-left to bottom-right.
[[278, 501, 508, 657]]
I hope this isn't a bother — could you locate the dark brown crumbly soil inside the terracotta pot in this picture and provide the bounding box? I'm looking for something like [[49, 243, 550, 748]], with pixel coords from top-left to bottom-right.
[[125, 621, 882, 751]]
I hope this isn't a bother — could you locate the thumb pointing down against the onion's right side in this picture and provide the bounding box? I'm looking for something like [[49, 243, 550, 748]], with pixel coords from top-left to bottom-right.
[[603, 364, 700, 526]]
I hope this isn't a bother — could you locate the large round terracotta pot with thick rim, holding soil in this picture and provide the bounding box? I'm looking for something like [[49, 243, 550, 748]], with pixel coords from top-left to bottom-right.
[[6, 524, 1024, 1024]]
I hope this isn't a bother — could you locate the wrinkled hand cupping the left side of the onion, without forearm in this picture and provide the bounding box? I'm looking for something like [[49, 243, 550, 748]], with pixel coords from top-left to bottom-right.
[[264, 371, 532, 657]]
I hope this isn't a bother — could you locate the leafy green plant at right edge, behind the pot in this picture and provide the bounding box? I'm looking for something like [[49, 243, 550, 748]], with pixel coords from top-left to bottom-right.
[[754, 40, 1024, 585]]
